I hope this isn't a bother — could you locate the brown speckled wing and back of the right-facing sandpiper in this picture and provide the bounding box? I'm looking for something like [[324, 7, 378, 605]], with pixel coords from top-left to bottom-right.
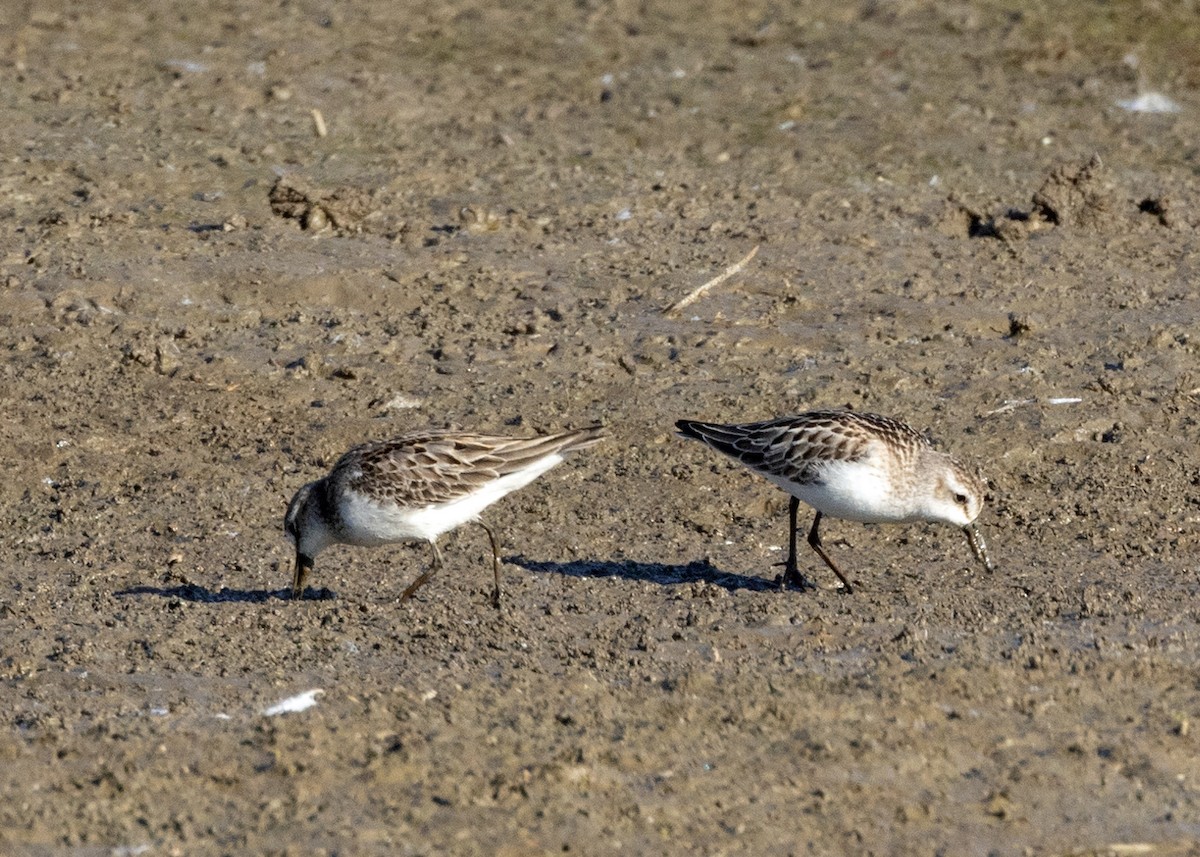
[[677, 410, 929, 485]]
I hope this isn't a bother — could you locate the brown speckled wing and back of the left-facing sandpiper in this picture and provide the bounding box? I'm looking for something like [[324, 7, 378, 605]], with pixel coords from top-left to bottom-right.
[[330, 426, 604, 507]]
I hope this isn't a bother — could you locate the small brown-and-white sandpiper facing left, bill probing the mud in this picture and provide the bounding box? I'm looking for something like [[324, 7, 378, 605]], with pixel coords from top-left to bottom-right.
[[283, 426, 604, 607]]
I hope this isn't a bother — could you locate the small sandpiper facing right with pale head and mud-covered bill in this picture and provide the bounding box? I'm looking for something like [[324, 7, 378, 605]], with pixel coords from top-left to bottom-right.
[[676, 410, 995, 593]]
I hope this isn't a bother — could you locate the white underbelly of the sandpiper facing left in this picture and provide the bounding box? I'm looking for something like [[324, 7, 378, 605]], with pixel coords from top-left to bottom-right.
[[341, 455, 563, 547]]
